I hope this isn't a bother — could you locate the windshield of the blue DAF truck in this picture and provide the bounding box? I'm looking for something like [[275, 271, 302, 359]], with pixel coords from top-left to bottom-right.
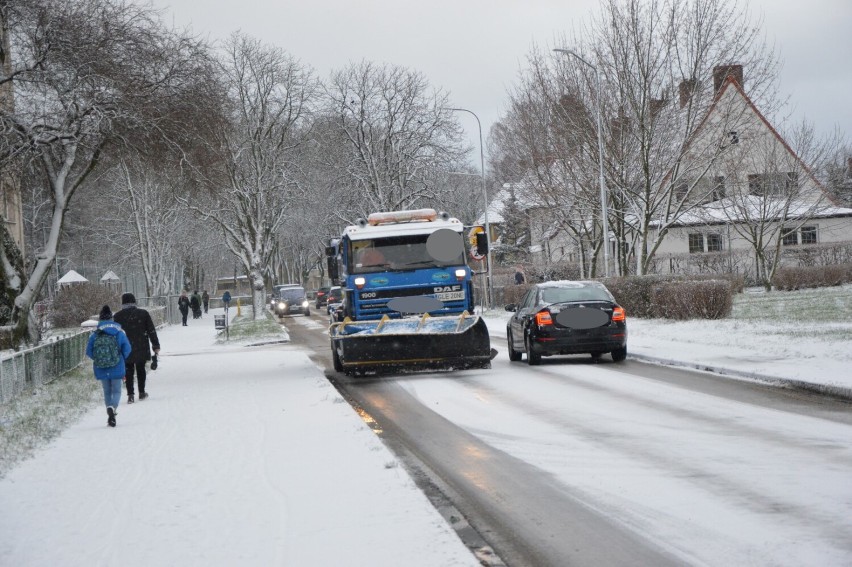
[[349, 234, 464, 274]]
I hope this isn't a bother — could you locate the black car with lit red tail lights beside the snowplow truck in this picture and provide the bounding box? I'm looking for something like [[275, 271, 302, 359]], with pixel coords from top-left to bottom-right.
[[506, 281, 627, 365]]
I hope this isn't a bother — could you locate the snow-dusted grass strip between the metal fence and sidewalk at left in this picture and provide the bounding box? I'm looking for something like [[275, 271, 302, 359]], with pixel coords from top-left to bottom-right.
[[0, 364, 103, 478]]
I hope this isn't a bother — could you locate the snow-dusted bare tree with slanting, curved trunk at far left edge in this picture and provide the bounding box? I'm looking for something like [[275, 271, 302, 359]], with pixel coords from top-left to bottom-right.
[[0, 0, 212, 346]]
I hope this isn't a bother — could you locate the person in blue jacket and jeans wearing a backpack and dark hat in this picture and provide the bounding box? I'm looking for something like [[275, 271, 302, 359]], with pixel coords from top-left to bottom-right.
[[86, 305, 131, 427]]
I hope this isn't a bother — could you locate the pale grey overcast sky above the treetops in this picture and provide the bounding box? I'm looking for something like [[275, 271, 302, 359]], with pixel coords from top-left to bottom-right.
[[150, 0, 852, 155]]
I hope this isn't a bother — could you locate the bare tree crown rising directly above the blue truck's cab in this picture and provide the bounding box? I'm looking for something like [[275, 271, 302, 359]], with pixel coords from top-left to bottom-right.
[[322, 62, 466, 221]]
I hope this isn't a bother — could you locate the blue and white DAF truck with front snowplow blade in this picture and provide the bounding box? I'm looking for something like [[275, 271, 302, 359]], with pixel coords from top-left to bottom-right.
[[326, 209, 492, 375]]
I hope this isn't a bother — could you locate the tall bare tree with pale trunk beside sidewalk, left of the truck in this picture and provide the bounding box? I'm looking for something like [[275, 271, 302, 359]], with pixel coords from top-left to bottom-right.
[[187, 34, 318, 319]]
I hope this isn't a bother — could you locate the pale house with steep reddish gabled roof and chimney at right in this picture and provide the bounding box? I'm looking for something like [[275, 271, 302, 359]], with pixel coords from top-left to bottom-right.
[[644, 65, 852, 272]]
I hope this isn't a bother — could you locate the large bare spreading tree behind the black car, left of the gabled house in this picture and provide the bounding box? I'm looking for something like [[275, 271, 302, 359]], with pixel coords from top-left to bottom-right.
[[496, 0, 783, 274]]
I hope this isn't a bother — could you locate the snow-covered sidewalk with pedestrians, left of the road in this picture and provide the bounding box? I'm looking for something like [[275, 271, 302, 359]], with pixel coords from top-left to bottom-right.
[[0, 310, 479, 567]]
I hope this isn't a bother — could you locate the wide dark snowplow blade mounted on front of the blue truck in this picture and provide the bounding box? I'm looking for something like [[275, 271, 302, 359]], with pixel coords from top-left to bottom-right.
[[329, 312, 492, 374]]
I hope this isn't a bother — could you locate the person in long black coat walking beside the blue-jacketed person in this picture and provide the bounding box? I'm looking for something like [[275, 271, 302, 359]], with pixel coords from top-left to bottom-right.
[[113, 293, 160, 404]]
